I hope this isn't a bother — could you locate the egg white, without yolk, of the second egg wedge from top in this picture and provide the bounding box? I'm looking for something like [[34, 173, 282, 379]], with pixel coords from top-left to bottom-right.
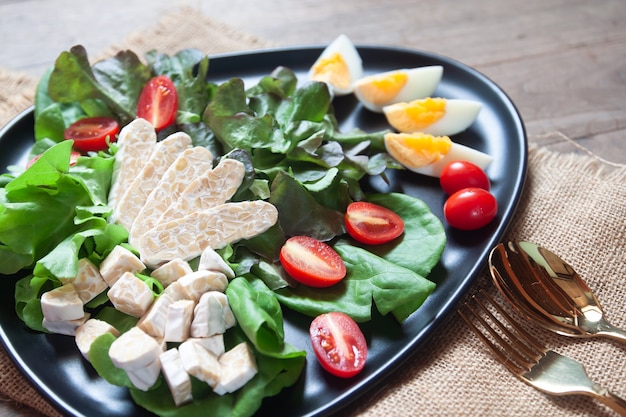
[[354, 65, 443, 113]]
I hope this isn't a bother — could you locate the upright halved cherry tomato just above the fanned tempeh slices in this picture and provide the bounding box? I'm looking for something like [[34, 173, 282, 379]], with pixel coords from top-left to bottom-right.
[[137, 75, 178, 131]]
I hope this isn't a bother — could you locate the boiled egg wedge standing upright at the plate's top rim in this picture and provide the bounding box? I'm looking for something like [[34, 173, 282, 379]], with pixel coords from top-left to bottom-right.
[[309, 35, 363, 96]]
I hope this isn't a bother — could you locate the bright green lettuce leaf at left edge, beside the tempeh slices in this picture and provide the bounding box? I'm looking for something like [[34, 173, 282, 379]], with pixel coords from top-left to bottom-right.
[[0, 141, 116, 276]]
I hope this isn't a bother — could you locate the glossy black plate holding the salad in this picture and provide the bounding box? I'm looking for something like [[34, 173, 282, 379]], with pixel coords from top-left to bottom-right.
[[0, 46, 527, 417]]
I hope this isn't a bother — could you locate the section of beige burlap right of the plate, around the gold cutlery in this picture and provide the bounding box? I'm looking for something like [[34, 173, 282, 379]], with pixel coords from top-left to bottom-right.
[[352, 142, 626, 417]]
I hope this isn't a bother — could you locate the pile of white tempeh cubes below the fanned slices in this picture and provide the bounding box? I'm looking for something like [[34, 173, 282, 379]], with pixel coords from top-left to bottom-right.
[[41, 248, 257, 406]]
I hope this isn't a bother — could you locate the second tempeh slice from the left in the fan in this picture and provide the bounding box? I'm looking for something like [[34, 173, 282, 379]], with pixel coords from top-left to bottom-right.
[[115, 132, 191, 230]]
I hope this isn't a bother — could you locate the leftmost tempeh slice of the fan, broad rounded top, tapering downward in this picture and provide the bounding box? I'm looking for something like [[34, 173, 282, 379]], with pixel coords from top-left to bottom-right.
[[108, 119, 156, 213]]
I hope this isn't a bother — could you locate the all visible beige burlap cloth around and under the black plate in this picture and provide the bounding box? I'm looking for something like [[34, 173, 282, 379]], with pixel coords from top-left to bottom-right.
[[0, 9, 626, 417]]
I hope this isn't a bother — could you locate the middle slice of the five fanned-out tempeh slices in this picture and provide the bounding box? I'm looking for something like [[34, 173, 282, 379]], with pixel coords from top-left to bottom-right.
[[128, 146, 213, 247]]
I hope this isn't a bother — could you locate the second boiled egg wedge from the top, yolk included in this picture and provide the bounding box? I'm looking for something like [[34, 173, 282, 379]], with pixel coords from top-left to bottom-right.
[[354, 65, 443, 113]]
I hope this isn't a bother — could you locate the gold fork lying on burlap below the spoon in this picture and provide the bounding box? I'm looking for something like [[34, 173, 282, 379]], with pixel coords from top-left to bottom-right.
[[458, 290, 626, 416]]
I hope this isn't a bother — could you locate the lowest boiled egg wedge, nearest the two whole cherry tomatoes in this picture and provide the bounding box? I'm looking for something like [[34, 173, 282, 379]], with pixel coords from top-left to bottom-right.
[[385, 132, 493, 177]]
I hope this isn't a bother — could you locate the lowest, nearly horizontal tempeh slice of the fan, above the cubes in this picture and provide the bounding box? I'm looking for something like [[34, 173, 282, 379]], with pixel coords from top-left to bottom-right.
[[140, 200, 278, 267]]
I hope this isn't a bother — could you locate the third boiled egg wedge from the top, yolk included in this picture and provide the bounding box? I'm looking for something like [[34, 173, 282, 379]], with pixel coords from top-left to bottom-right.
[[383, 97, 482, 136]]
